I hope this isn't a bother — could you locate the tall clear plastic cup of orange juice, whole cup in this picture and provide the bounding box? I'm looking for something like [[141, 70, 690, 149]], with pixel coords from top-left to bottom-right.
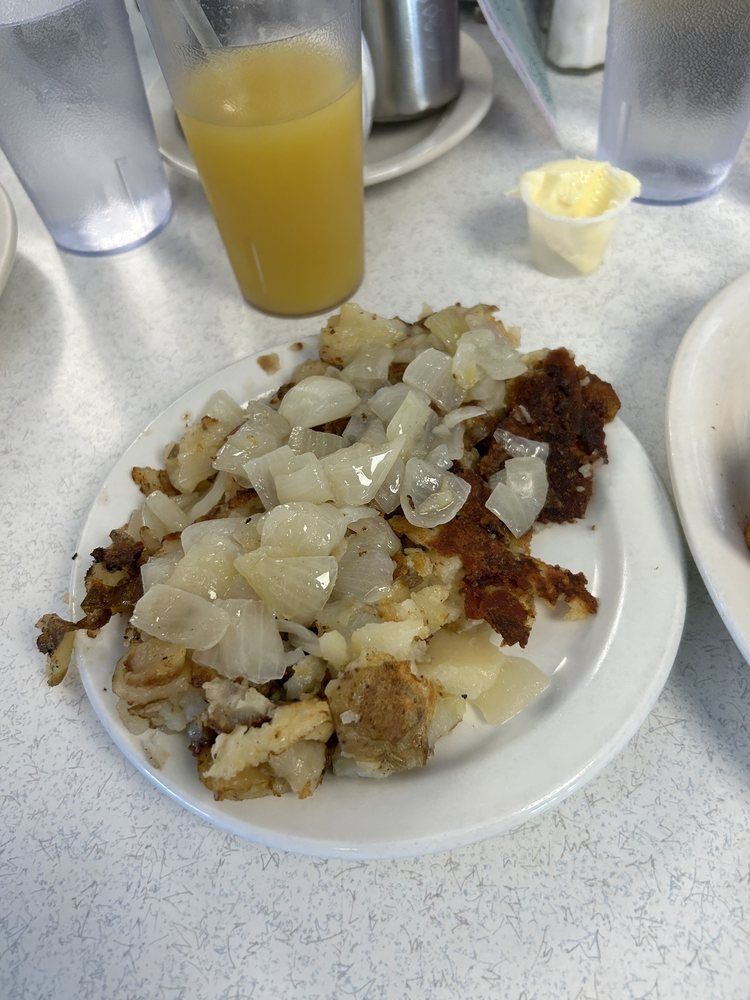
[[140, 0, 364, 315]]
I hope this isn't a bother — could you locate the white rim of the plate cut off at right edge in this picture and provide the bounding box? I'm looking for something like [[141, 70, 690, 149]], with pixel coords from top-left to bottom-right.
[[665, 271, 750, 663]]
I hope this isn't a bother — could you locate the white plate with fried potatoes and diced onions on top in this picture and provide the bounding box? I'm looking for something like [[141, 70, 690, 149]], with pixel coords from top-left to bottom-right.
[[38, 304, 685, 857]]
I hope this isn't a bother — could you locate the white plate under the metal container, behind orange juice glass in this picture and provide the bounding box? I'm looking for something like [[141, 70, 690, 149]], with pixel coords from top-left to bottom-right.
[[148, 32, 493, 187]]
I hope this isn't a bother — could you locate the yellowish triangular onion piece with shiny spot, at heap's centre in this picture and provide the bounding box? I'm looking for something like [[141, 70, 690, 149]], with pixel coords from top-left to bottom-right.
[[235, 548, 338, 625]]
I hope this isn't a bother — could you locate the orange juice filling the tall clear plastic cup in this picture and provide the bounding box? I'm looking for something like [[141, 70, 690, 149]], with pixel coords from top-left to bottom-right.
[[177, 38, 363, 315]]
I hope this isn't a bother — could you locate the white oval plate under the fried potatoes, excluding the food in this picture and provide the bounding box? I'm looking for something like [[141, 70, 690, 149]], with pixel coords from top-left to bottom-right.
[[71, 338, 685, 858]]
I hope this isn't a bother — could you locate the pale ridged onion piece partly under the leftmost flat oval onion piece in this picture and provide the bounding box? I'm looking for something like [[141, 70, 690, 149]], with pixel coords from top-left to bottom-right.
[[193, 599, 286, 684]]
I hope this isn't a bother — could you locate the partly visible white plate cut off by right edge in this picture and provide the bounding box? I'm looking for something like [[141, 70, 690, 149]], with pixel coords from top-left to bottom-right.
[[667, 274, 750, 662]]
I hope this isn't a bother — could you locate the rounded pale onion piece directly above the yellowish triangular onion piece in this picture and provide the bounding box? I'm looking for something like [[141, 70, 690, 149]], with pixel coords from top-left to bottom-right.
[[261, 503, 348, 556]]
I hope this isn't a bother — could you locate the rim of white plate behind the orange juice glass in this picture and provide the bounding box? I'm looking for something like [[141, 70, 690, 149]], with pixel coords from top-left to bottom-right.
[[146, 30, 494, 188]]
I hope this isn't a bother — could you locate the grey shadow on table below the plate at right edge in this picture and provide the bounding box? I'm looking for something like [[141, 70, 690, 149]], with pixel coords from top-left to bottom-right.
[[670, 561, 750, 780]]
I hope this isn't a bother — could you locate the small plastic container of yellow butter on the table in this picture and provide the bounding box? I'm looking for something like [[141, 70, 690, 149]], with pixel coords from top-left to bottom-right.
[[518, 160, 641, 278]]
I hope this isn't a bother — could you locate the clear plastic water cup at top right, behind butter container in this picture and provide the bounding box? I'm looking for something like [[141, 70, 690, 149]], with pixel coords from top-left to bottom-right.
[[598, 0, 750, 202]]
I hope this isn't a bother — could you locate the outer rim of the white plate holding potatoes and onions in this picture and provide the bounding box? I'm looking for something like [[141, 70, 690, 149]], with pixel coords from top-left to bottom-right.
[[70, 337, 687, 859]]
